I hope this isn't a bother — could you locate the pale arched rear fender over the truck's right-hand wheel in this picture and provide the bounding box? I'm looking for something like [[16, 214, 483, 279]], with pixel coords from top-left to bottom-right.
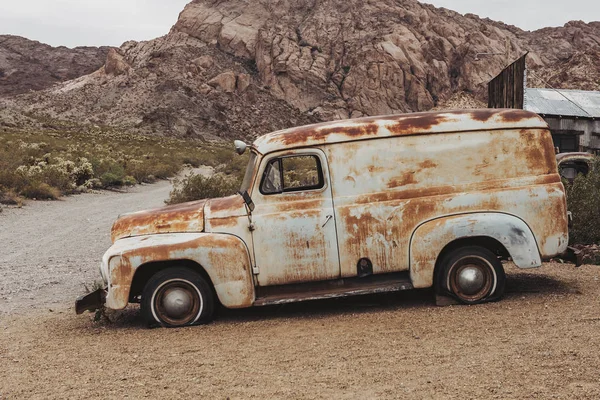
[[410, 213, 542, 288]]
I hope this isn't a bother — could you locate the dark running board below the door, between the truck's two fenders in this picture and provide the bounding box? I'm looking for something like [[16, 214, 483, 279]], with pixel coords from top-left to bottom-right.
[[254, 274, 413, 306]]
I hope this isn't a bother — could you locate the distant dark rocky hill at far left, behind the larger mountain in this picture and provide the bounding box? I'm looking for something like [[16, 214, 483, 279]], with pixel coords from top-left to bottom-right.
[[0, 35, 108, 97]]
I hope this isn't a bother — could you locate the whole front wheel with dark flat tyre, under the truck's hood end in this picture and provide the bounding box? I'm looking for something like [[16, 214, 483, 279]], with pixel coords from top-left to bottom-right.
[[141, 267, 214, 328]]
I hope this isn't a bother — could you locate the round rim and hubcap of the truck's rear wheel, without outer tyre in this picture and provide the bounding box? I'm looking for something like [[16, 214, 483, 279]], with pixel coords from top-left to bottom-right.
[[448, 256, 496, 302]]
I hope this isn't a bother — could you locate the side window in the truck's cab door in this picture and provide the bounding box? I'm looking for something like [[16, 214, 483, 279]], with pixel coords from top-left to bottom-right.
[[260, 155, 324, 194]]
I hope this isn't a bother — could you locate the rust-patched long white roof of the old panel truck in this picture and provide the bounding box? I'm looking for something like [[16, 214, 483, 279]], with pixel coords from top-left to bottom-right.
[[253, 108, 548, 154]]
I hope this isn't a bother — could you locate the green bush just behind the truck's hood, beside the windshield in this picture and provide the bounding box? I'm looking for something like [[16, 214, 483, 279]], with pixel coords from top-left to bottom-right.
[[166, 174, 241, 204]]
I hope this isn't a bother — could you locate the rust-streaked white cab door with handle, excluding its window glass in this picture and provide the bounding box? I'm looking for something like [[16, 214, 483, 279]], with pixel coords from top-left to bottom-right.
[[252, 149, 340, 286]]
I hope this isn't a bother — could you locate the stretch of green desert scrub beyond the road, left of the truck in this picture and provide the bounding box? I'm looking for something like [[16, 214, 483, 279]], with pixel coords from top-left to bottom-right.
[[0, 125, 244, 204]]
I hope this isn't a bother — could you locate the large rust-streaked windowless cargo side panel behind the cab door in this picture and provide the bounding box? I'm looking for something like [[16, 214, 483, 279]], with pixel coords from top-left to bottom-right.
[[324, 129, 567, 276]]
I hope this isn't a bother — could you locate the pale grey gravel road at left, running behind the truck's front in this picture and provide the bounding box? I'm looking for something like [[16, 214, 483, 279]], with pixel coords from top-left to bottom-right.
[[0, 181, 172, 316]]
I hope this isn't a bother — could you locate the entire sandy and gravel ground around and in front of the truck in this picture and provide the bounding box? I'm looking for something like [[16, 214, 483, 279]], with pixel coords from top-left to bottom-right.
[[0, 182, 600, 399]]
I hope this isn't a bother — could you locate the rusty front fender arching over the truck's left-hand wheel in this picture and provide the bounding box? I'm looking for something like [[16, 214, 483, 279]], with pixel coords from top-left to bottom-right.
[[104, 233, 254, 310]]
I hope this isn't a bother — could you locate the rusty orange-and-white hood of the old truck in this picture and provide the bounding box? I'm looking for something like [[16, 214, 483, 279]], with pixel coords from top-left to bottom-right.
[[110, 200, 207, 243]]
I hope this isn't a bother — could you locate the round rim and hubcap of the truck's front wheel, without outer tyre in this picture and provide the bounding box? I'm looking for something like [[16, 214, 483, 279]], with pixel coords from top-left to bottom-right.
[[152, 279, 202, 326]]
